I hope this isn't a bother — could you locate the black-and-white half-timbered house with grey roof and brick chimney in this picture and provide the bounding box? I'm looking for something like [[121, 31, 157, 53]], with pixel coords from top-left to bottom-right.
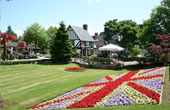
[[67, 24, 95, 55]]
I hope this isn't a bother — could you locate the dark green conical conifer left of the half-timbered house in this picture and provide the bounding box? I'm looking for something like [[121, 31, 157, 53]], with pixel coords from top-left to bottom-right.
[[51, 22, 72, 63]]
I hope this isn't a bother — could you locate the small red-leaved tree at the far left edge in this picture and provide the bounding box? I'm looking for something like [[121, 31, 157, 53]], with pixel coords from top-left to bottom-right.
[[0, 32, 16, 60]]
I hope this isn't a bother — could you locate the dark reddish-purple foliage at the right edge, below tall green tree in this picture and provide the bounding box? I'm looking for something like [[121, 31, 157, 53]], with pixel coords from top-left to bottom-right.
[[147, 34, 170, 64]]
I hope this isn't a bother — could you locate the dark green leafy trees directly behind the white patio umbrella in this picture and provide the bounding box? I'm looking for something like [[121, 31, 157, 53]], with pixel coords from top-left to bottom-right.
[[104, 19, 139, 50]]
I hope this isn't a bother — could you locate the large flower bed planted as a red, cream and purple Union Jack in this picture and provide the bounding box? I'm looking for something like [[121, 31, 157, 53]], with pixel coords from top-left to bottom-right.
[[32, 67, 165, 109]]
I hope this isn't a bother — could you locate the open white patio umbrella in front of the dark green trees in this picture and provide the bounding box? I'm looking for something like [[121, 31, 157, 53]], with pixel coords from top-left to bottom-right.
[[99, 44, 124, 63]]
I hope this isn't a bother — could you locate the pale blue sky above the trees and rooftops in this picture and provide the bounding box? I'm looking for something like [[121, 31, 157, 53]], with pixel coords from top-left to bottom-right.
[[0, 0, 161, 35]]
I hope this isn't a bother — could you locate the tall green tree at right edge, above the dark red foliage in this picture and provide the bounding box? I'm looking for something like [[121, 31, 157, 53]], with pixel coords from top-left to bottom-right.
[[138, 0, 170, 47]]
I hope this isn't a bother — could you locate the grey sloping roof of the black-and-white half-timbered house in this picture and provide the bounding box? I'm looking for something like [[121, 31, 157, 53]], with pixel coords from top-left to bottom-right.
[[70, 25, 94, 42]]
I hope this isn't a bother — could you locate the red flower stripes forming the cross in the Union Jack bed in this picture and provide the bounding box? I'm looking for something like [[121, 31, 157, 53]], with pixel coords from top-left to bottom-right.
[[68, 67, 163, 108]]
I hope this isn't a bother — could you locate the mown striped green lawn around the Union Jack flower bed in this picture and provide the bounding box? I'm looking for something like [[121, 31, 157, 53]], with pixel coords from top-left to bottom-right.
[[0, 64, 170, 110]]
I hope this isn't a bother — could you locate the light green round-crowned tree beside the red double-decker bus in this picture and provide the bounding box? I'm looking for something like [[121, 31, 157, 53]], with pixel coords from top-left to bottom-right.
[[23, 23, 48, 53]]
